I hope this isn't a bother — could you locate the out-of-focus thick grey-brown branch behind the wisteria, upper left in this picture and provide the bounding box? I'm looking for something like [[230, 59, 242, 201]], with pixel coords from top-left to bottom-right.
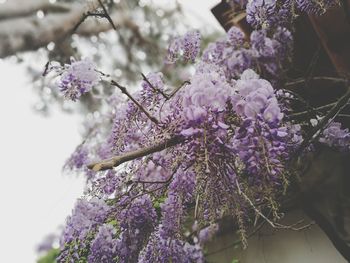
[[0, 0, 137, 58]]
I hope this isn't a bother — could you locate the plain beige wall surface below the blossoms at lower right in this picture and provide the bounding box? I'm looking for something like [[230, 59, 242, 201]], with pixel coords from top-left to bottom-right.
[[208, 210, 347, 263]]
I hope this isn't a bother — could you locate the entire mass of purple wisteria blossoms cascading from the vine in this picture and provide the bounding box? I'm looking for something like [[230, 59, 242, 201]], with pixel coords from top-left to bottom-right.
[[43, 0, 350, 263]]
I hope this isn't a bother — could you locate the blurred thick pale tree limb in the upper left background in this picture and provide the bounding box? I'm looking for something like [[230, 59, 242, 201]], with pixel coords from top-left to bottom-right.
[[0, 0, 123, 58]]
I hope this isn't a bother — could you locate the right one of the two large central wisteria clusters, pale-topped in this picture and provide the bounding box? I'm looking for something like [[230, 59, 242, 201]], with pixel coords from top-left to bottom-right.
[[232, 71, 289, 182]]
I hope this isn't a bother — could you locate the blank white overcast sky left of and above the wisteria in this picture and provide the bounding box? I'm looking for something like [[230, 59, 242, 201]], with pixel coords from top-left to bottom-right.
[[0, 0, 220, 263]]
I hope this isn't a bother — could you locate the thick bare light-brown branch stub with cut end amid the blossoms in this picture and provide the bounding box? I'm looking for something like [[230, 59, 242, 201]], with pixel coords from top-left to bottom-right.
[[88, 136, 184, 172]]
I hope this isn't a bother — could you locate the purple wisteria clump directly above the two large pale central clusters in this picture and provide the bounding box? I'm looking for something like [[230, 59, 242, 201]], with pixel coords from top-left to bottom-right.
[[202, 27, 293, 81]]
